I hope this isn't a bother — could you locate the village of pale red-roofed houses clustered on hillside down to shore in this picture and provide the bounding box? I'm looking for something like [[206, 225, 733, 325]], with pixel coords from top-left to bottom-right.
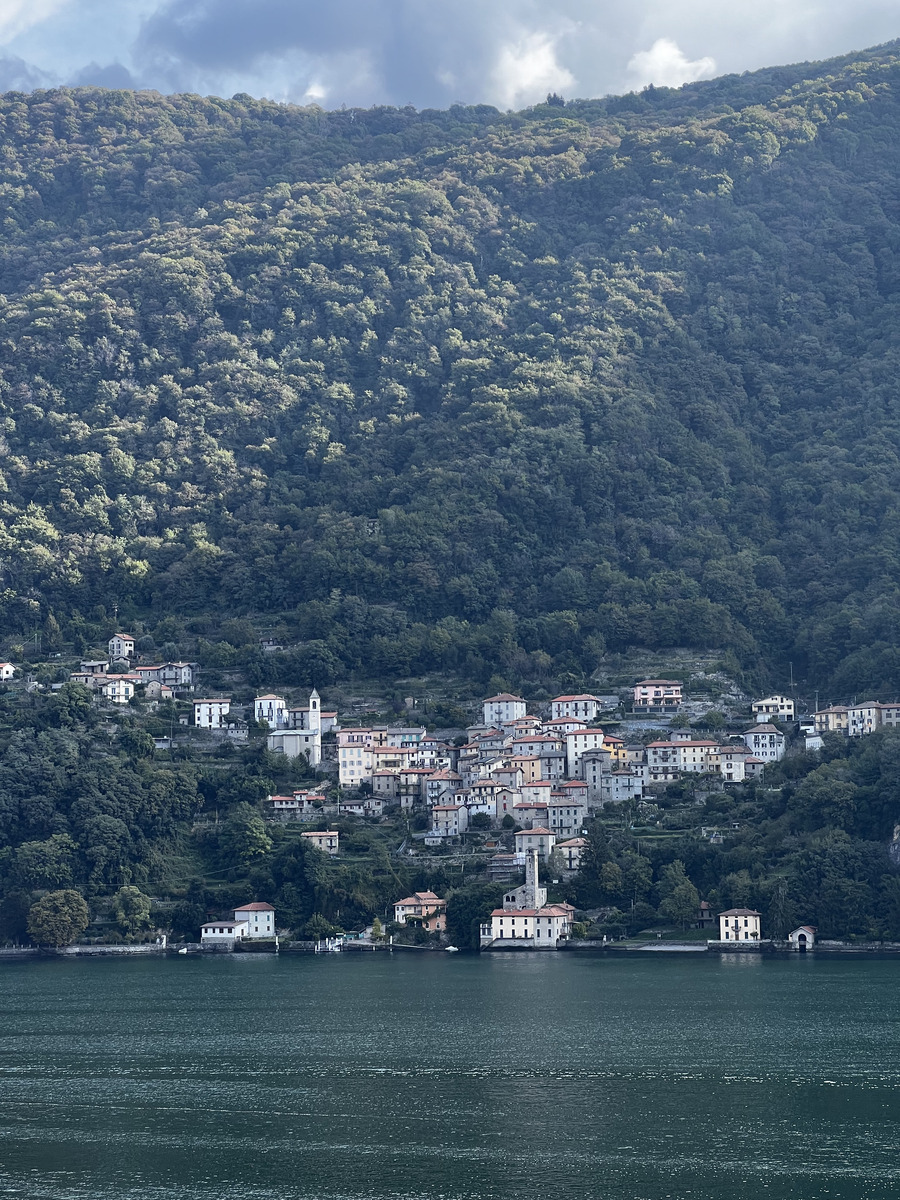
[[0, 632, 900, 949]]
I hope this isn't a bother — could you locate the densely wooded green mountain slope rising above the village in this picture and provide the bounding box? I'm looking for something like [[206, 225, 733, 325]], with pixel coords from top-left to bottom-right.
[[0, 43, 900, 697]]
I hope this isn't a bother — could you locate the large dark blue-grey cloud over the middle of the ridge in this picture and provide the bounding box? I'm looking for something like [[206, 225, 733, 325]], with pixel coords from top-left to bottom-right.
[[134, 0, 573, 106]]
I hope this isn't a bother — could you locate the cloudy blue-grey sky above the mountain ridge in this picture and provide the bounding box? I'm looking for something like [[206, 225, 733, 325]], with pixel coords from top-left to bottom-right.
[[0, 0, 900, 109]]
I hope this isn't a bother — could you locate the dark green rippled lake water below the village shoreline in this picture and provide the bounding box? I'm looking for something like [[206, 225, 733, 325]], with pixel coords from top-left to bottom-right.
[[0, 954, 900, 1200]]
